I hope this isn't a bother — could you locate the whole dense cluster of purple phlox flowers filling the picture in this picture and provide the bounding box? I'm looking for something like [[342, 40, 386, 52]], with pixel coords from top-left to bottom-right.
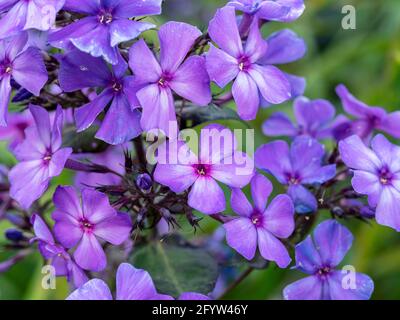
[[0, 0, 400, 300]]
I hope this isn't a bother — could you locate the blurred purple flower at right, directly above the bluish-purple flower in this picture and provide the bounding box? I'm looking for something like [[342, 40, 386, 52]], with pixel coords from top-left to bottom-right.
[[263, 97, 348, 139]]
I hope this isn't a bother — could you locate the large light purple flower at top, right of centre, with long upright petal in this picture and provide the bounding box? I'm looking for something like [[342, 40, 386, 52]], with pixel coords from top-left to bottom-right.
[[206, 6, 291, 120]]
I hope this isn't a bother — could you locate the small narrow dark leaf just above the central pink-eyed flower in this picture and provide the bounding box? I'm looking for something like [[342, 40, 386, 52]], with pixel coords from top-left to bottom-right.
[[182, 104, 243, 127]]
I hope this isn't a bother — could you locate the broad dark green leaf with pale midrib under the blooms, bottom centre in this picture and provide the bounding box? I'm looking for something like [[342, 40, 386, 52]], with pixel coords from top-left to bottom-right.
[[131, 242, 218, 297]]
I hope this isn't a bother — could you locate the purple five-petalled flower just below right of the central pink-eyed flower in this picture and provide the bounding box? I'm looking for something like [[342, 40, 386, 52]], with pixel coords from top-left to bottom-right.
[[224, 174, 294, 268]]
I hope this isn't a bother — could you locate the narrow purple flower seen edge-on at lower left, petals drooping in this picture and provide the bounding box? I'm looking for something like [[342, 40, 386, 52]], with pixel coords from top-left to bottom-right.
[[31, 214, 88, 288]]
